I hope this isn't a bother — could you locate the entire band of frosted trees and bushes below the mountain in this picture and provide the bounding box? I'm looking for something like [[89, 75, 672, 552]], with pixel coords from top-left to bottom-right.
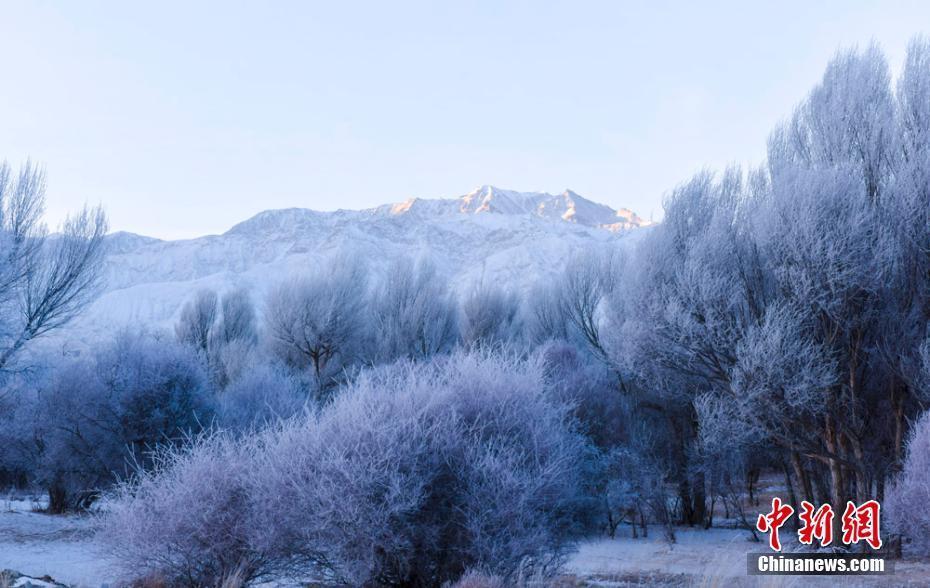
[[0, 40, 930, 586]]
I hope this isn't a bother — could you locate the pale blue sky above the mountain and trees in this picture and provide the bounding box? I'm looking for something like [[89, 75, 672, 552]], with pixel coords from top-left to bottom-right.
[[0, 0, 930, 238]]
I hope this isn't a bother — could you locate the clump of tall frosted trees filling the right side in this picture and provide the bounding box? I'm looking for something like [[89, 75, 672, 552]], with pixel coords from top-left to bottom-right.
[[607, 40, 930, 532]]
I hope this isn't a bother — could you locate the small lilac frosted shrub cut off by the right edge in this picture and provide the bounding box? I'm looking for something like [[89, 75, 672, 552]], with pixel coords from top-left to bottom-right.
[[884, 412, 930, 556]]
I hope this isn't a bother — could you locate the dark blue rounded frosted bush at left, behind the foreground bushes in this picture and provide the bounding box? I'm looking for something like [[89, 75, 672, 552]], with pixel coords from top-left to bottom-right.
[[36, 333, 212, 512]]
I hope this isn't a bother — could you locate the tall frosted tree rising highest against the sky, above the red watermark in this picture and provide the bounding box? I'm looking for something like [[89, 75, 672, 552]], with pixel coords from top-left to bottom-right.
[[759, 44, 930, 516]]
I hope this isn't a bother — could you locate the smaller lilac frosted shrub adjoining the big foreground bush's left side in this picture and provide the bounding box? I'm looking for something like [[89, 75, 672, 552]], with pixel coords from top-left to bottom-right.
[[101, 434, 268, 586]]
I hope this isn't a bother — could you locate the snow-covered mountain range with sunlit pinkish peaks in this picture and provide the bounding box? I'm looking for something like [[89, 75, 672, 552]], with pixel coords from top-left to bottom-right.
[[50, 186, 651, 340]]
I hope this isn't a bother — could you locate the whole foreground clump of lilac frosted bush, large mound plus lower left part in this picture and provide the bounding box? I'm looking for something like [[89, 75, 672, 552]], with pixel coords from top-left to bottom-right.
[[104, 353, 585, 586]]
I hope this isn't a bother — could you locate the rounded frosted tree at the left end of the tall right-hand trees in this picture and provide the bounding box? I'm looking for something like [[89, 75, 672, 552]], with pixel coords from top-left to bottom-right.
[[605, 170, 766, 524]]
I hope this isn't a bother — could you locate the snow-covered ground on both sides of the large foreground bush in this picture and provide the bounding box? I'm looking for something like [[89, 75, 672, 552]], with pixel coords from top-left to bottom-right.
[[0, 498, 930, 588]]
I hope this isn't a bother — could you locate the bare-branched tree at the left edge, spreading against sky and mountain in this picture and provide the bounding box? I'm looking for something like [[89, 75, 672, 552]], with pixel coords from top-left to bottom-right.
[[0, 162, 107, 370]]
